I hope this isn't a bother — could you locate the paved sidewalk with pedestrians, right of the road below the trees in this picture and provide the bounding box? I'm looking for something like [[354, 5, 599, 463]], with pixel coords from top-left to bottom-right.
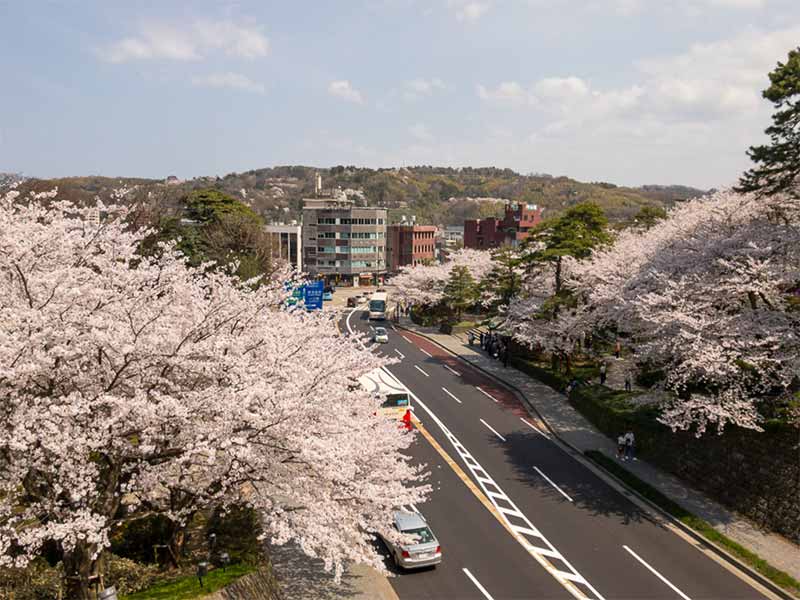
[[400, 318, 800, 580]]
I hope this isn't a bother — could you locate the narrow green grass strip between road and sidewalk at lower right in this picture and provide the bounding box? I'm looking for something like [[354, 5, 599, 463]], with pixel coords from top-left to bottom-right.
[[585, 450, 800, 597]]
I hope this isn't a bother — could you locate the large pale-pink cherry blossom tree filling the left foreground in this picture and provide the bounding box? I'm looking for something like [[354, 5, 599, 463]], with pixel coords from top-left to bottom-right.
[[0, 192, 429, 598]]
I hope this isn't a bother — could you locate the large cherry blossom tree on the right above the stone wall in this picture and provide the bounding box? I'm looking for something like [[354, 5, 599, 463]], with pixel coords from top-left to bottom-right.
[[571, 191, 800, 435]]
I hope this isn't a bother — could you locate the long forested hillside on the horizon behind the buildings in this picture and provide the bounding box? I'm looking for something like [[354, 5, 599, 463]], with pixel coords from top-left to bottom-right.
[[6, 165, 704, 224]]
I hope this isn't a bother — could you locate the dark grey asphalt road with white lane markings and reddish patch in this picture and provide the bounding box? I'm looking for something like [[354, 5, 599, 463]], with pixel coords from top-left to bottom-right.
[[343, 310, 764, 600]]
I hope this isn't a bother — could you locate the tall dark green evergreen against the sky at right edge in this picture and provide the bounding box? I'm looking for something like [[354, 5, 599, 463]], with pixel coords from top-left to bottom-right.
[[737, 47, 800, 198]]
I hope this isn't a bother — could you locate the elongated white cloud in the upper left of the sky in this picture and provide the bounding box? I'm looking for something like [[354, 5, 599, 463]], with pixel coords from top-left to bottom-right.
[[98, 20, 269, 63]]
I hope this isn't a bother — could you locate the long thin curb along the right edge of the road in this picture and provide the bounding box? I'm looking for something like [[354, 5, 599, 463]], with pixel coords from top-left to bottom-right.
[[395, 323, 797, 600]]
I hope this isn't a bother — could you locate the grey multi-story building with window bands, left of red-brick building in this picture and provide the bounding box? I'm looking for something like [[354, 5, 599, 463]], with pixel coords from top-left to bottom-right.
[[303, 197, 387, 285]]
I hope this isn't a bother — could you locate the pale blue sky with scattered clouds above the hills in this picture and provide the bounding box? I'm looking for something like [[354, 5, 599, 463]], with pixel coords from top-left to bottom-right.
[[0, 0, 800, 187]]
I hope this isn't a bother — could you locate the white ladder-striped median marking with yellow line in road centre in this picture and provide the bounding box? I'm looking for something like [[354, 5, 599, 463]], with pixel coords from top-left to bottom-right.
[[400, 378, 605, 600]]
